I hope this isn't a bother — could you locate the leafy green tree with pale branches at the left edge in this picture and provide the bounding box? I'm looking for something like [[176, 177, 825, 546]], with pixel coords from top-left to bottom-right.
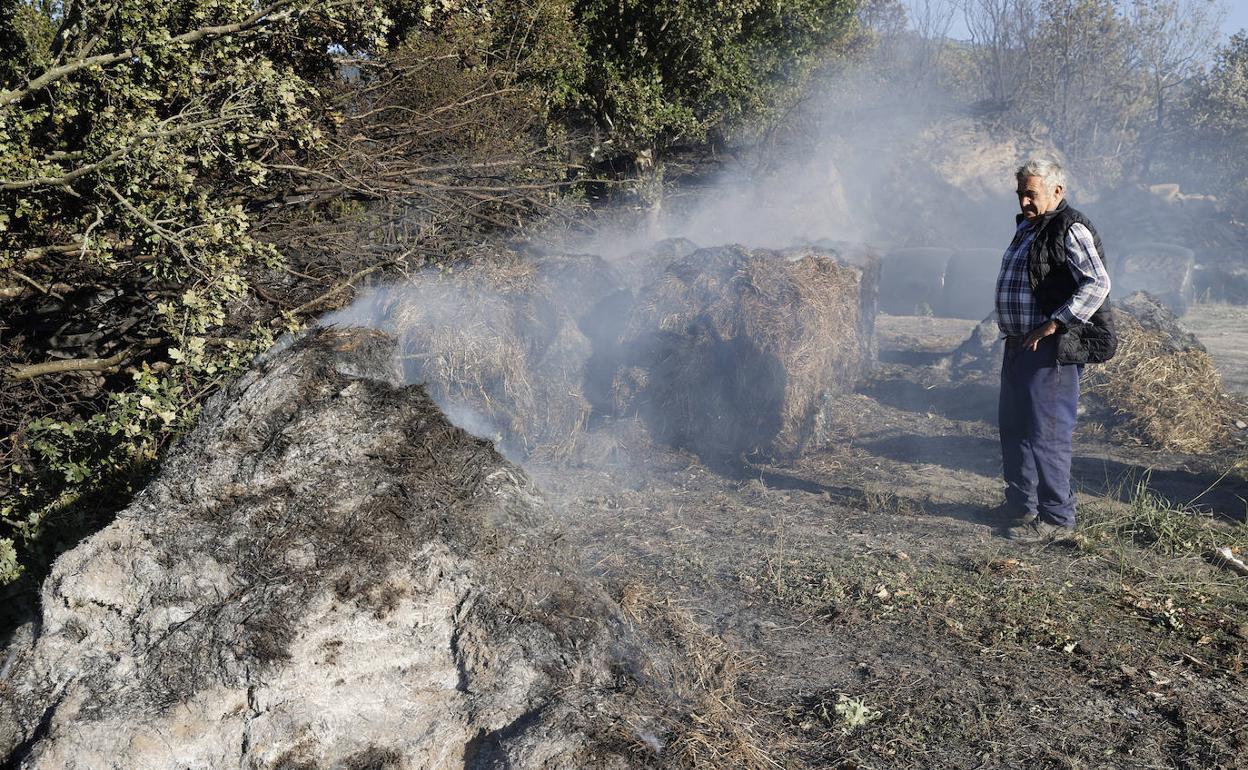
[[0, 0, 399, 582]]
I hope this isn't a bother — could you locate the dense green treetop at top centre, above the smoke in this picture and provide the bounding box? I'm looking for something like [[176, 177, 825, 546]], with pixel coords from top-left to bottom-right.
[[577, 0, 856, 151]]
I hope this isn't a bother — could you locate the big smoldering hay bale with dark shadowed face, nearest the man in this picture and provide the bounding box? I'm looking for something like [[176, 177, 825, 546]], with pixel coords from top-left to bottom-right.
[[614, 246, 877, 458]]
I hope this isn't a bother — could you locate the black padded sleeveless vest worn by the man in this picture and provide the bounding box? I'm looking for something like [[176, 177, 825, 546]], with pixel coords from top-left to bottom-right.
[[1018, 201, 1118, 363]]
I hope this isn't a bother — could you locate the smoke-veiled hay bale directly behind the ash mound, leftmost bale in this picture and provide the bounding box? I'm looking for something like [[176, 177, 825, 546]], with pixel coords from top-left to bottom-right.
[[387, 258, 590, 458]]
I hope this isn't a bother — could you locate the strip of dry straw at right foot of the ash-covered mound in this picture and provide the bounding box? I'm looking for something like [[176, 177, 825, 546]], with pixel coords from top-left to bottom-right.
[[620, 584, 784, 770]]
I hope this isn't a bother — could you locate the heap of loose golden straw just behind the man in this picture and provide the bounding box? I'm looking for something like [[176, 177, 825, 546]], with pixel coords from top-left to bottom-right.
[[1086, 313, 1236, 454]]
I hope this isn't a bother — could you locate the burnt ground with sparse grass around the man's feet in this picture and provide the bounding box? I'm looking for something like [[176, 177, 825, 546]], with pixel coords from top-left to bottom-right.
[[537, 308, 1248, 769]]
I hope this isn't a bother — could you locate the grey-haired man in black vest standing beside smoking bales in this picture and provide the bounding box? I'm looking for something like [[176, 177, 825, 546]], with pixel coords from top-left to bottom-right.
[[997, 160, 1117, 542]]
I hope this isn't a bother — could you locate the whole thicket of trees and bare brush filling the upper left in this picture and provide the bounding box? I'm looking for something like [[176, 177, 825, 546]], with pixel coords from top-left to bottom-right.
[[0, 0, 855, 584]]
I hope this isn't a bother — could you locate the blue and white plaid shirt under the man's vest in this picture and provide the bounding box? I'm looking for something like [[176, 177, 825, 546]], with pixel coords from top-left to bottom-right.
[[997, 220, 1109, 337]]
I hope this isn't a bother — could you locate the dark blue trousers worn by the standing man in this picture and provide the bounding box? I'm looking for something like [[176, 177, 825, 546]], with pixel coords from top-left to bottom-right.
[[997, 334, 1083, 527]]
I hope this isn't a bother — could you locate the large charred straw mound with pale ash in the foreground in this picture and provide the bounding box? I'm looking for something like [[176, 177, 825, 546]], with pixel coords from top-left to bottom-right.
[[0, 331, 763, 770]]
